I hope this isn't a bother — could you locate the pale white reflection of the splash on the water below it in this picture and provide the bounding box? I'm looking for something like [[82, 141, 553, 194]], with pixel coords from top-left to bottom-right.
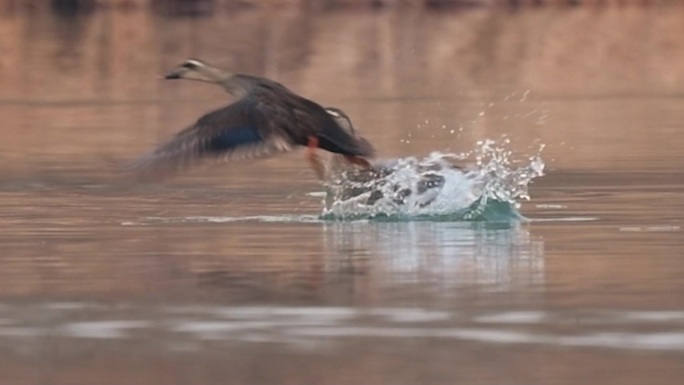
[[324, 222, 544, 296]]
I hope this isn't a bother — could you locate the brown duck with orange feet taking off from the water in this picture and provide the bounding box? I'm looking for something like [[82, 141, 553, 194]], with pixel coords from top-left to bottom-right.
[[131, 59, 375, 177]]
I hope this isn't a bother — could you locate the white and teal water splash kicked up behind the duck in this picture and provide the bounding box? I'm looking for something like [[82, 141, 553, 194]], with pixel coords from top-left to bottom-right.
[[322, 138, 544, 222]]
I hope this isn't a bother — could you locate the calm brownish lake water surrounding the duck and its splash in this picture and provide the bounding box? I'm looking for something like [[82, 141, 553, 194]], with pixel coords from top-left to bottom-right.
[[0, 3, 684, 385]]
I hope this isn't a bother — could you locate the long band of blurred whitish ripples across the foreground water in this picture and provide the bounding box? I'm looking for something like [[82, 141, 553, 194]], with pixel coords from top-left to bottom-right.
[[0, 302, 684, 352]]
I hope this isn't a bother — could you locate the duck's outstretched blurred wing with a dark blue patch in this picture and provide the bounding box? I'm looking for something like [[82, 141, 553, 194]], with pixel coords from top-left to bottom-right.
[[130, 99, 295, 178]]
